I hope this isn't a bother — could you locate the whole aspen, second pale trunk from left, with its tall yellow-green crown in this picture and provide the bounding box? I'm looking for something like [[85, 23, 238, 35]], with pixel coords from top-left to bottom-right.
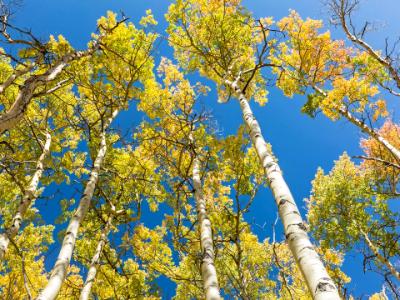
[[38, 13, 155, 299]]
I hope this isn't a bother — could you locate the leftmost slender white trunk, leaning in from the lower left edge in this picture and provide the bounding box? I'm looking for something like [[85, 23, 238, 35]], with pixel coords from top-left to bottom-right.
[[0, 132, 51, 261]]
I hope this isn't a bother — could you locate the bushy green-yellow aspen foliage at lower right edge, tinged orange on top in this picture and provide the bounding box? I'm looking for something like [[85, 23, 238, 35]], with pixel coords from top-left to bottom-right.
[[308, 123, 400, 299]]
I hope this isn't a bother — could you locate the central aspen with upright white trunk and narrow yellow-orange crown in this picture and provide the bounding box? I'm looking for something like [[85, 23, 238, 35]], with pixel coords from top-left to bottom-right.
[[140, 58, 221, 300]]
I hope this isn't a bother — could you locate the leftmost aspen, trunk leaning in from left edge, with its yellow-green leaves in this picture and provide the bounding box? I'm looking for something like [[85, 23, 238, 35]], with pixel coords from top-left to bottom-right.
[[0, 87, 79, 260]]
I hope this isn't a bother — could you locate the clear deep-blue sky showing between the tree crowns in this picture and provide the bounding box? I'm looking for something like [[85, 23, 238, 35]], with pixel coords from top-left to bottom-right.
[[9, 0, 400, 299]]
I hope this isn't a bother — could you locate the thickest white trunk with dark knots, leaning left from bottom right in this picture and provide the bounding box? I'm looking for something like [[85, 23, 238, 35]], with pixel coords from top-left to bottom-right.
[[225, 78, 340, 300]]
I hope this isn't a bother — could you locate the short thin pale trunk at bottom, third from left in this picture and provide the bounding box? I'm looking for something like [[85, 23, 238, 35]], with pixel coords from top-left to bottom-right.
[[79, 214, 114, 300]]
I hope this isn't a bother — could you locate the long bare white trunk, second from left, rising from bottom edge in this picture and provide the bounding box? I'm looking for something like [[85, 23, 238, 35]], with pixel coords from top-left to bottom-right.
[[37, 111, 118, 300]]
